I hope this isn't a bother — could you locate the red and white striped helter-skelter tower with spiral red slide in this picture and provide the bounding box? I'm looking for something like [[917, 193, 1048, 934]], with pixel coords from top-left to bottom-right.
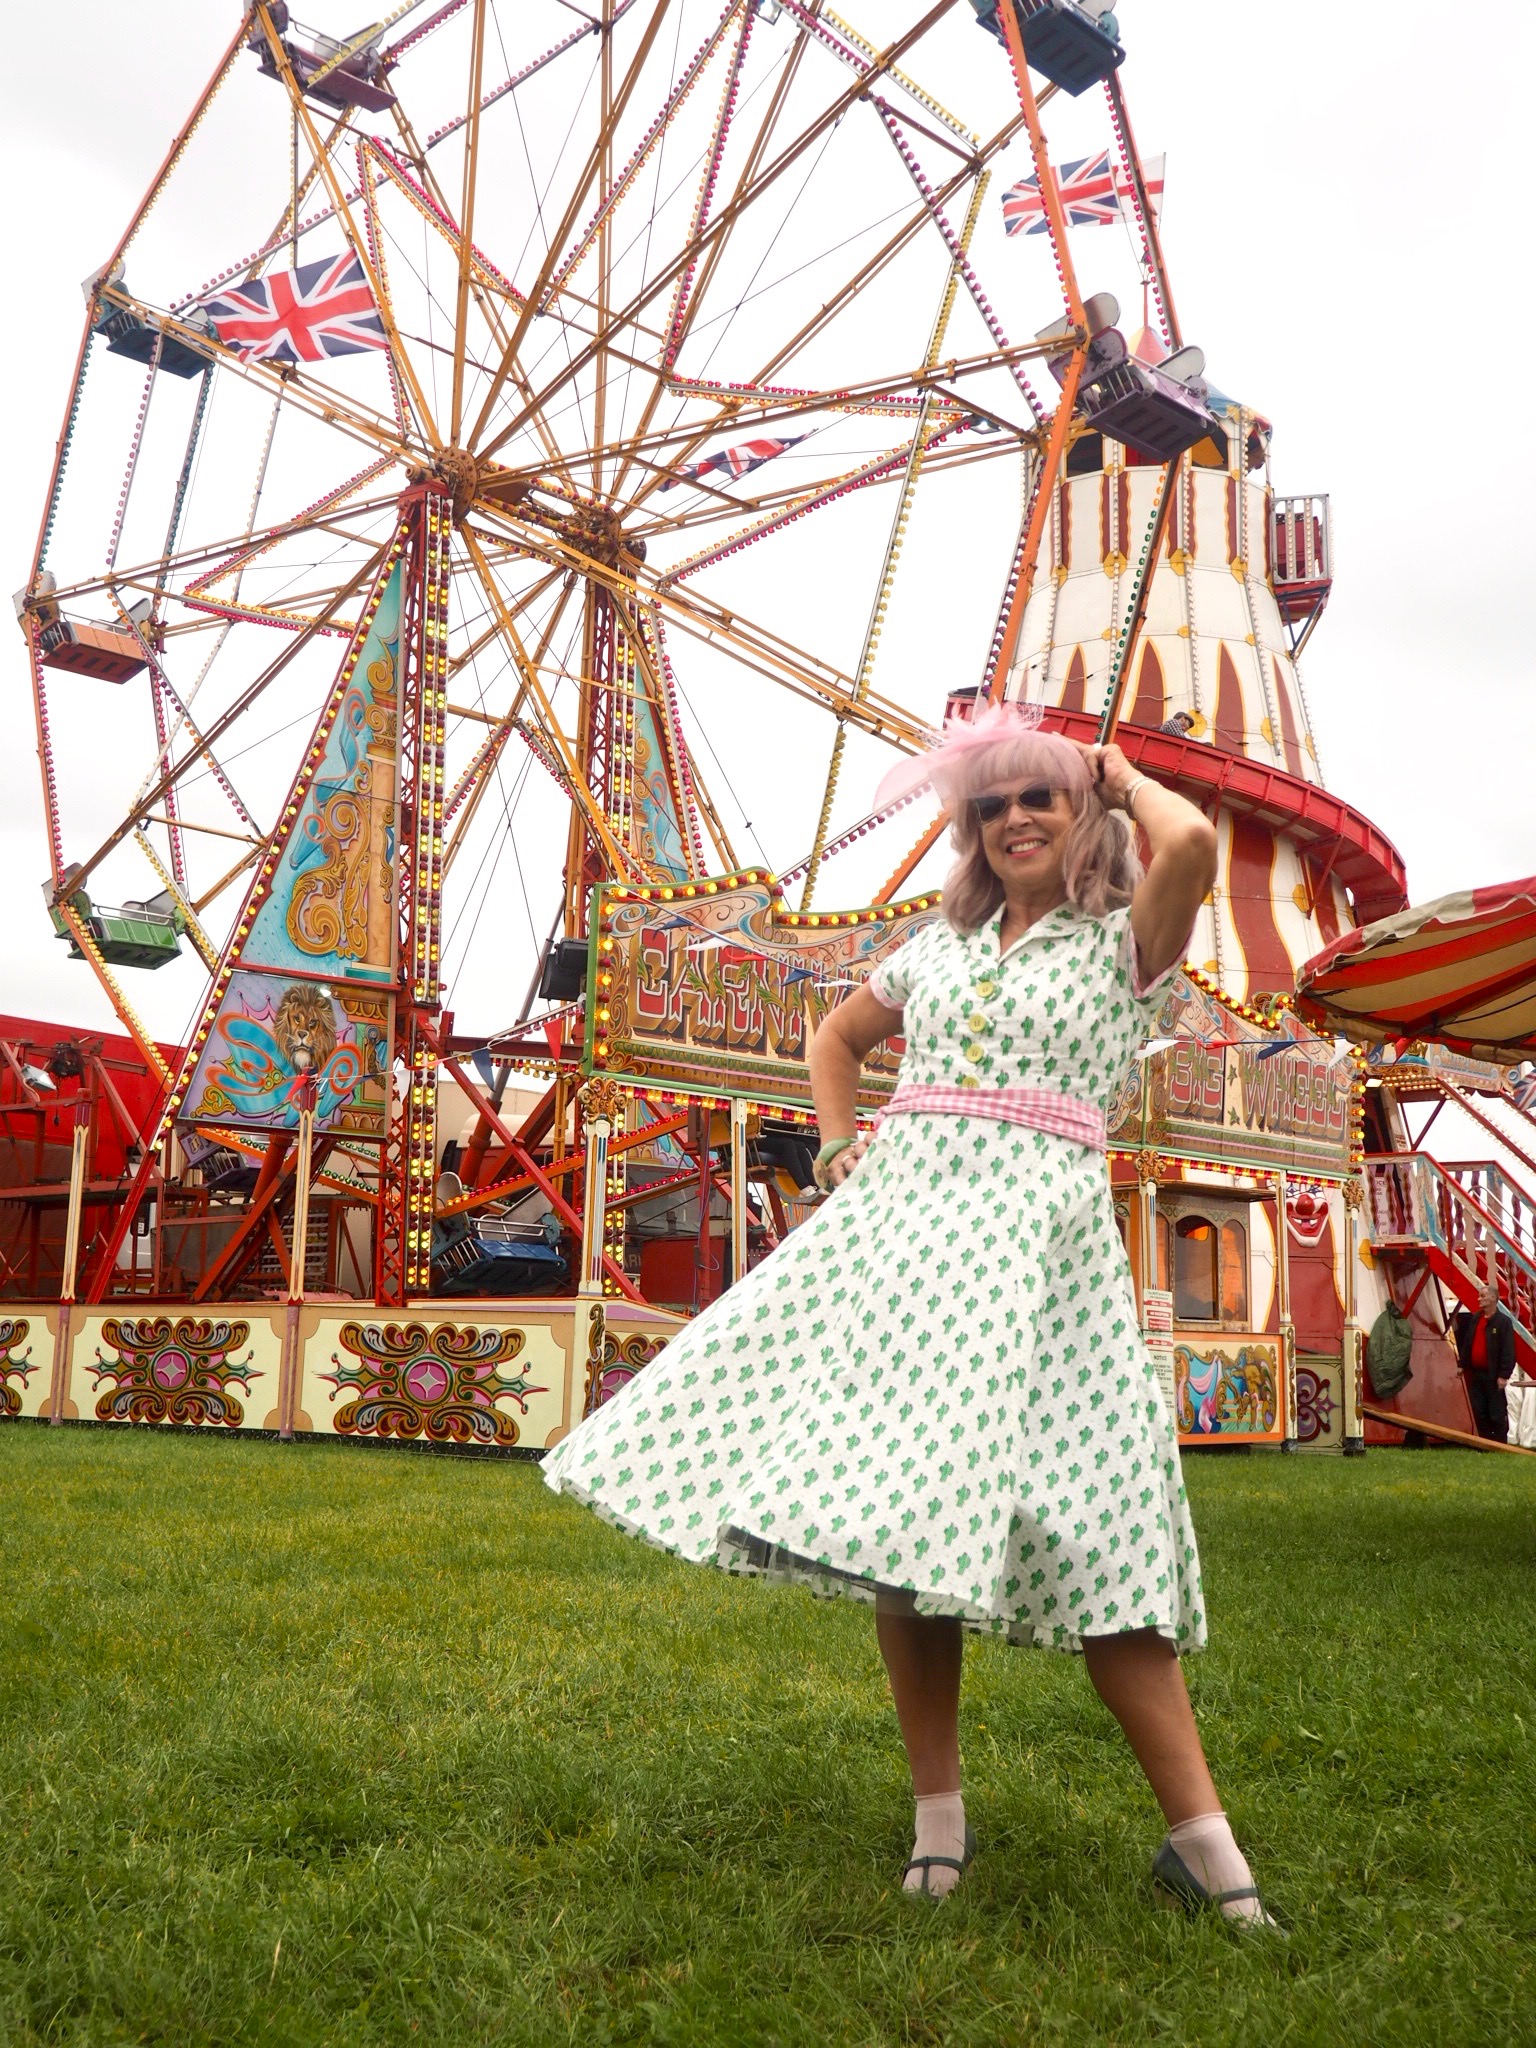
[[1006, 417, 1403, 997]]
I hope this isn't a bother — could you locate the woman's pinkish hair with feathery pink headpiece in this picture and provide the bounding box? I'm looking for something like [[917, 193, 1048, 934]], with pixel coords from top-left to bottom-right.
[[877, 705, 1141, 932]]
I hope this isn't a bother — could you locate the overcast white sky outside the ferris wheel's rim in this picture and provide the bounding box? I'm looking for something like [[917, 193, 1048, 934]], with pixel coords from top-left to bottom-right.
[[0, 0, 1536, 1056]]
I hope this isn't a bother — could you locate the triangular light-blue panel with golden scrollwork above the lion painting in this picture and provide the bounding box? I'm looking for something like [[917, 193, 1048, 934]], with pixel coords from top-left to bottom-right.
[[242, 565, 403, 985]]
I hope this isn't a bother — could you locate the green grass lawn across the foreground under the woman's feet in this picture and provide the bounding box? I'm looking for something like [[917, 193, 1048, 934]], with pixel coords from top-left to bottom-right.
[[0, 1425, 1536, 2048]]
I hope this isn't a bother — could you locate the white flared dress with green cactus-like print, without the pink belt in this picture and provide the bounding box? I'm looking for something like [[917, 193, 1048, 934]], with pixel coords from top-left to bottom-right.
[[545, 905, 1204, 1651]]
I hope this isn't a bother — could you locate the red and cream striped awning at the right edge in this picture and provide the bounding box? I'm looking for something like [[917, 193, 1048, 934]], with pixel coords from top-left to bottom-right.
[[1296, 874, 1536, 1061]]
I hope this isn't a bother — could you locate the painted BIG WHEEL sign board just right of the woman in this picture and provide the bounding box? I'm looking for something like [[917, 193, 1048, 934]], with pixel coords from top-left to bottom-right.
[[1110, 973, 1360, 1182]]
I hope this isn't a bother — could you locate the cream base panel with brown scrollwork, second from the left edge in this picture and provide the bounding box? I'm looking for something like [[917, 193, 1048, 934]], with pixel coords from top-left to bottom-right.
[[66, 1305, 283, 1430]]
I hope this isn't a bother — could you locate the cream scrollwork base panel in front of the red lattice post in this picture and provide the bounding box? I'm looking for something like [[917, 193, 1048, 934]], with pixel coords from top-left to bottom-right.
[[295, 1300, 584, 1450]]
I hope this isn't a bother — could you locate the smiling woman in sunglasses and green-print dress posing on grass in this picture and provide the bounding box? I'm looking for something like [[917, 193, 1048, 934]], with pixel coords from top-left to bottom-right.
[[545, 707, 1268, 1923]]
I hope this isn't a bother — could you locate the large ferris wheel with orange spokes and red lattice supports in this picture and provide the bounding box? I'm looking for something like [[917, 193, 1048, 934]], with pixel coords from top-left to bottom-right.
[[18, 0, 1161, 1298]]
